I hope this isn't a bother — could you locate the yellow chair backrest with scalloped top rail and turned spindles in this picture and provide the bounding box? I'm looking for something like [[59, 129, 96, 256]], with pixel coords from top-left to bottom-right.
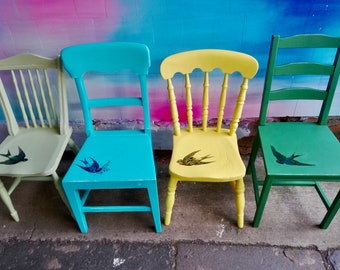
[[160, 49, 258, 135]]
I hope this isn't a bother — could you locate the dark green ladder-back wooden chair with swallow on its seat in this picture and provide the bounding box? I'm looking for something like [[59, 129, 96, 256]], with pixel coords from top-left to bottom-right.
[[247, 35, 340, 228]]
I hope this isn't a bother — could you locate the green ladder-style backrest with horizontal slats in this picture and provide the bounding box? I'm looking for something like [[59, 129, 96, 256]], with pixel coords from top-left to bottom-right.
[[259, 34, 340, 125]]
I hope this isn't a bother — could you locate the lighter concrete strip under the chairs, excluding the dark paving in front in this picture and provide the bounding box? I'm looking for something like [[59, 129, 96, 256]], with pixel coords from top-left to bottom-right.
[[0, 151, 340, 250]]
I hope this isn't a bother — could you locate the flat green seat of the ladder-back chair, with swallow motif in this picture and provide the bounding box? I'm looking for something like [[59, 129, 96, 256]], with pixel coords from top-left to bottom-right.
[[259, 122, 340, 178]]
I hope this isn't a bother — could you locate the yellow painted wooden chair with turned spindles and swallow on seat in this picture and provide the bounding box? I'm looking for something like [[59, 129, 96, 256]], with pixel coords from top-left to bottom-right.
[[160, 49, 258, 228]]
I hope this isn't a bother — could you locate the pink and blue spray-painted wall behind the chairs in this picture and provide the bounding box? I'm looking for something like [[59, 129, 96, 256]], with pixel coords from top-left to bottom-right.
[[0, 0, 340, 125]]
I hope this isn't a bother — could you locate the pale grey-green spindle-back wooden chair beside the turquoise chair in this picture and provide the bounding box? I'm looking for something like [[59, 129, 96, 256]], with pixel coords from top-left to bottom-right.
[[0, 54, 78, 221]]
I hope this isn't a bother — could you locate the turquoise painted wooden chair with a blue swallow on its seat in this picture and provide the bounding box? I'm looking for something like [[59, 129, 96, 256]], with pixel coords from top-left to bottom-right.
[[61, 42, 162, 233]]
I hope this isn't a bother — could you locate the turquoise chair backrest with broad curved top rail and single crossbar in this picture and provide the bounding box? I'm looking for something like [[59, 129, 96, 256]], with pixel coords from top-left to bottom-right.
[[61, 42, 151, 136]]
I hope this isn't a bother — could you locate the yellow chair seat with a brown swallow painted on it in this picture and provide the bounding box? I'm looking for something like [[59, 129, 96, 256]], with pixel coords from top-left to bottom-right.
[[169, 128, 245, 182]]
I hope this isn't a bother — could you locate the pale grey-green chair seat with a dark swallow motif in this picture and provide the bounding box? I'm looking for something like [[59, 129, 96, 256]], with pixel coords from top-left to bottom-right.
[[0, 128, 72, 177]]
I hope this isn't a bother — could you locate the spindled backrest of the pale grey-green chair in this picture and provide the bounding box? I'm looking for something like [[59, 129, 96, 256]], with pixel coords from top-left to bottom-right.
[[0, 54, 69, 135]]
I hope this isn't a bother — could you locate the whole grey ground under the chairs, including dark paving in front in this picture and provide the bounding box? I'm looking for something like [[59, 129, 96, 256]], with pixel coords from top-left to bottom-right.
[[0, 151, 340, 270]]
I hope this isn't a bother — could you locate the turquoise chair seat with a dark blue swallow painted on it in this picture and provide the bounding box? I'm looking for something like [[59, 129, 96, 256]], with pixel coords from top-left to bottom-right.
[[63, 131, 156, 189]]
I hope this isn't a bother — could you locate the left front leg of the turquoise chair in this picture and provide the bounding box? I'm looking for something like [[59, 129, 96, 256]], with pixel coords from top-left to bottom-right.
[[64, 186, 88, 233]]
